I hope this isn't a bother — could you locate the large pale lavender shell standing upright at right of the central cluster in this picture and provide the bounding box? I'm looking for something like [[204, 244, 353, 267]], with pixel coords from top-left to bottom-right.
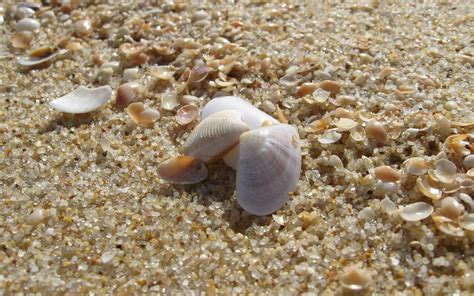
[[237, 124, 301, 215]]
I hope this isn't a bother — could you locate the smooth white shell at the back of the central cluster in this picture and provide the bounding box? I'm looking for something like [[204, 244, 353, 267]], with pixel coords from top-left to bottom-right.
[[201, 96, 278, 129]]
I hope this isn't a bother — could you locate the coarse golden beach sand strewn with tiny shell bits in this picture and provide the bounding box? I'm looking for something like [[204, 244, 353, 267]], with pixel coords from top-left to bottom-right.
[[0, 0, 474, 295]]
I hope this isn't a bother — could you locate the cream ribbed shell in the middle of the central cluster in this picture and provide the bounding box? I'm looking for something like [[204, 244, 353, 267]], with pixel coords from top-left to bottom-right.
[[184, 111, 249, 163]]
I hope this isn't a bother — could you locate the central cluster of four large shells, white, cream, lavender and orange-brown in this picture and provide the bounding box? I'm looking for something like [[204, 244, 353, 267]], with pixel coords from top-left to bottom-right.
[[158, 96, 301, 215]]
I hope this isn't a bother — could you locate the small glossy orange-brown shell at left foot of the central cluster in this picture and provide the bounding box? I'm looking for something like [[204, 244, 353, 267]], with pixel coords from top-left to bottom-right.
[[158, 156, 207, 184]]
